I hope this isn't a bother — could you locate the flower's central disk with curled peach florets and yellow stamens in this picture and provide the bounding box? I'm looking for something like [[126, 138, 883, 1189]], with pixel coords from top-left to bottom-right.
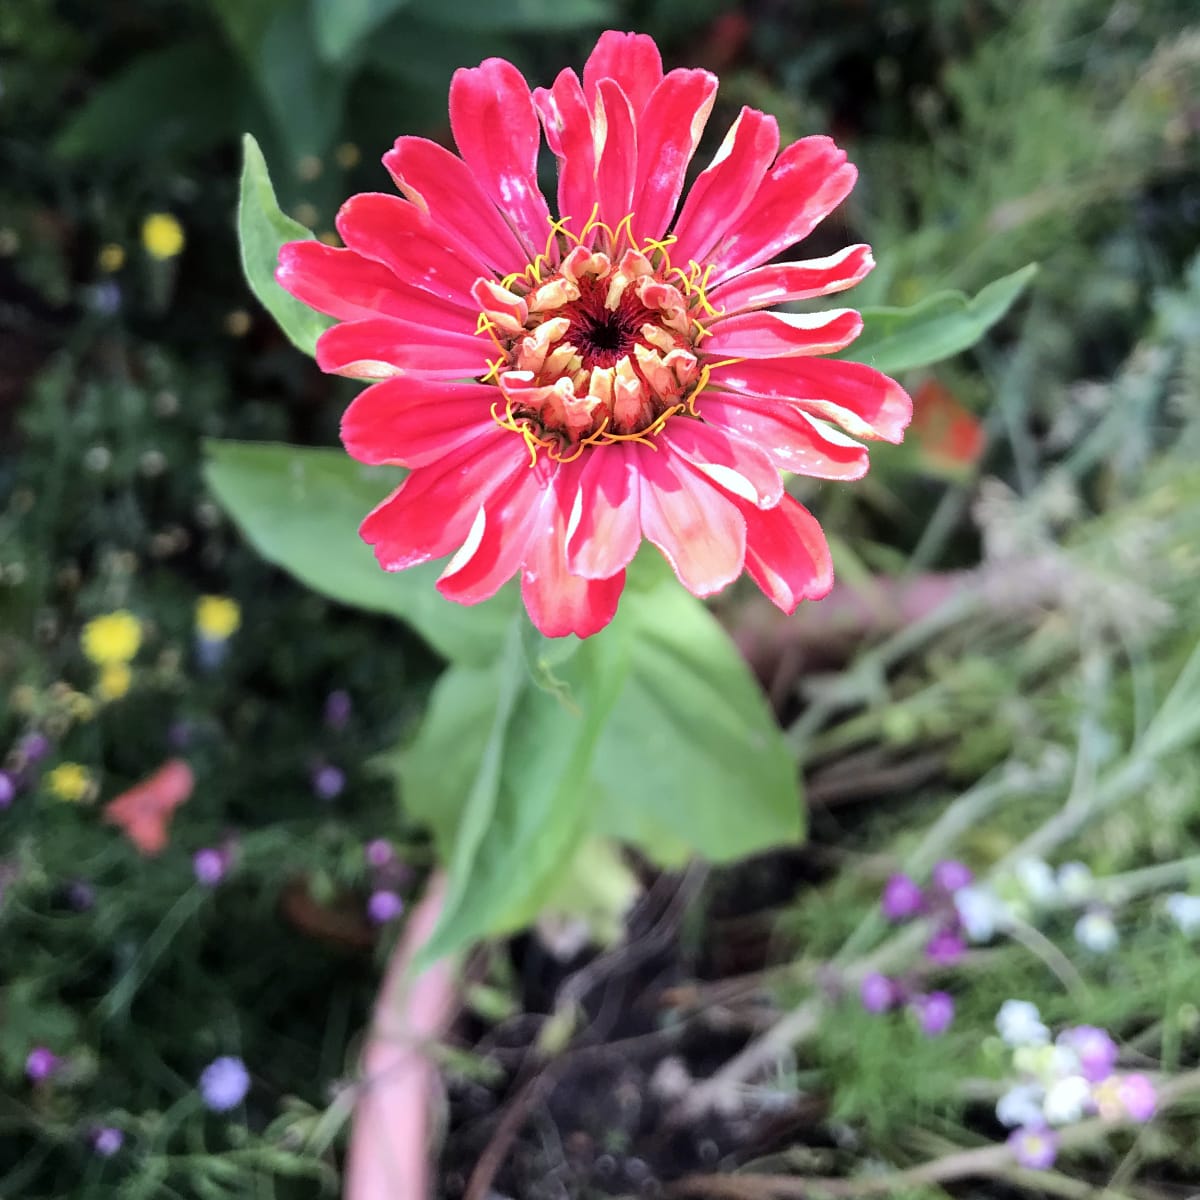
[[474, 222, 712, 462]]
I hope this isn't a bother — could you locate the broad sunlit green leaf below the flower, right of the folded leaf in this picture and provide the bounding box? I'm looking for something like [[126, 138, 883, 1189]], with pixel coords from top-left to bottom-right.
[[593, 578, 803, 865]]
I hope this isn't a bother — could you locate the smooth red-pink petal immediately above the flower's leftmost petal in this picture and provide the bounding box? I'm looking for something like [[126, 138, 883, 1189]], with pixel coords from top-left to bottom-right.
[[335, 192, 485, 314]]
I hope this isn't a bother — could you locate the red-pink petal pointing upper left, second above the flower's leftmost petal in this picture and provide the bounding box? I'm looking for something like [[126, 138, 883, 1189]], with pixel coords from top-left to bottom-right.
[[383, 138, 524, 275]]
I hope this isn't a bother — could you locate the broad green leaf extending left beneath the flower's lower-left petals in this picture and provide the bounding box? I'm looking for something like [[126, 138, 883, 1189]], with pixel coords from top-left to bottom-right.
[[205, 442, 516, 662]]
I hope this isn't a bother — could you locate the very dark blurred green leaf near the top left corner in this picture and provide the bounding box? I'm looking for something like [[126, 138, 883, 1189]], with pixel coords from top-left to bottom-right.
[[54, 38, 247, 164]]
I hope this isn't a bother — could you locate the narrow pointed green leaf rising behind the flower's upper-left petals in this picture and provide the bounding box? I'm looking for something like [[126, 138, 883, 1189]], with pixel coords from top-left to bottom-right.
[[238, 133, 334, 355]]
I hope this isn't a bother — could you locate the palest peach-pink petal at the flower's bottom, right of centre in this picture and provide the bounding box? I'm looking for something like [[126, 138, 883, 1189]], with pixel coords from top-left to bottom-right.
[[635, 445, 746, 596]]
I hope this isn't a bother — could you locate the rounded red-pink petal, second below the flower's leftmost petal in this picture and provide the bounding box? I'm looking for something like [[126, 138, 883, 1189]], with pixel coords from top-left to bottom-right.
[[342, 376, 496, 467]]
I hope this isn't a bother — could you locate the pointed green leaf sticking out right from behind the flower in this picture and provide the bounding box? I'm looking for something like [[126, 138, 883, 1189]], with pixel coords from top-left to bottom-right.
[[840, 263, 1038, 374]]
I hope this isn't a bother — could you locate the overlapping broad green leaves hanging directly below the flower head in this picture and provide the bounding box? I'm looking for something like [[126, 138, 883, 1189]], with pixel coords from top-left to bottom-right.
[[390, 556, 802, 953]]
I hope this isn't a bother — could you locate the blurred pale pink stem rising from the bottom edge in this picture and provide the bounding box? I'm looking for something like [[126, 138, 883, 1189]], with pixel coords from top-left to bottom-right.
[[343, 872, 460, 1200]]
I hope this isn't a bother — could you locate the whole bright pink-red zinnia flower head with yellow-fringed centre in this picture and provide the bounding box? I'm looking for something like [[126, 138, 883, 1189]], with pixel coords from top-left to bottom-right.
[[277, 32, 912, 636]]
